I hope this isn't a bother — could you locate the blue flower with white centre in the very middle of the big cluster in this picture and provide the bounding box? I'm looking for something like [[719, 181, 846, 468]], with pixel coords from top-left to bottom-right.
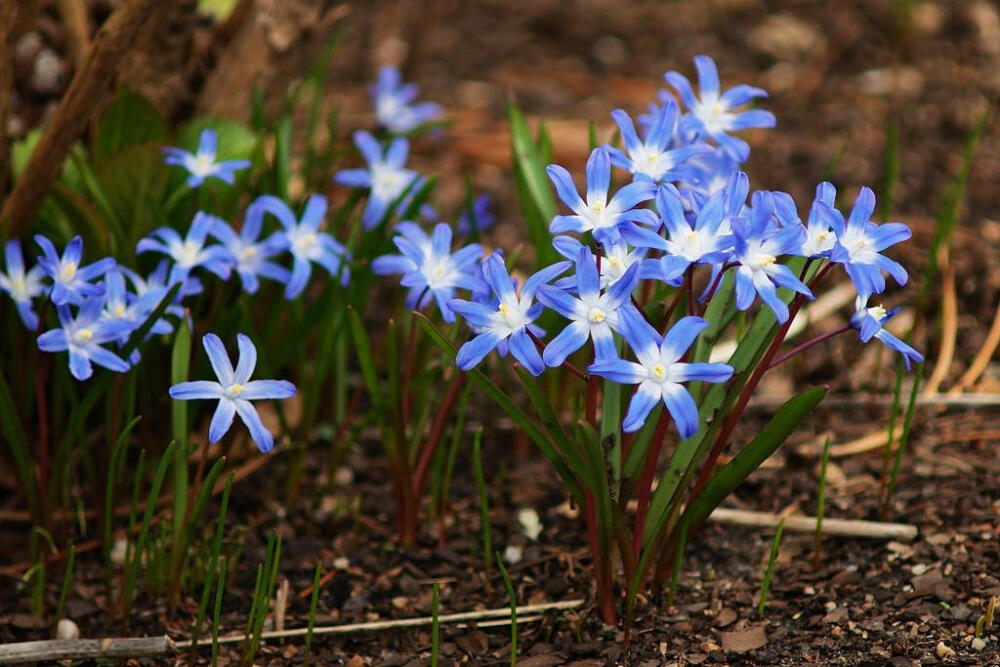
[[646, 187, 733, 286]]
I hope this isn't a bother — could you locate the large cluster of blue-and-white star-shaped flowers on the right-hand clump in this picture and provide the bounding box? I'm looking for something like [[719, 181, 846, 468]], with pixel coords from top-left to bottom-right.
[[360, 56, 922, 437]]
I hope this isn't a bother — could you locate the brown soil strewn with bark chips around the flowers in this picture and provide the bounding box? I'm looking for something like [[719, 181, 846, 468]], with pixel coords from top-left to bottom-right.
[[0, 0, 1000, 667]]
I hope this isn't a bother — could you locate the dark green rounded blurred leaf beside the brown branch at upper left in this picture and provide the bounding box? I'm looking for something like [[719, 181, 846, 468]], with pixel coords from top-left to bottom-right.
[[93, 88, 167, 162]]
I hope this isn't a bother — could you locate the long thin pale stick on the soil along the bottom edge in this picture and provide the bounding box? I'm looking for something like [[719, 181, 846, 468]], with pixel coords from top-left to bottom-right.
[[174, 600, 583, 651]]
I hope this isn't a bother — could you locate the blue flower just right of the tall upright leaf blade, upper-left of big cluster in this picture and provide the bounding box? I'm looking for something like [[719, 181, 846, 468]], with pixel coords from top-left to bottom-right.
[[545, 148, 665, 249]]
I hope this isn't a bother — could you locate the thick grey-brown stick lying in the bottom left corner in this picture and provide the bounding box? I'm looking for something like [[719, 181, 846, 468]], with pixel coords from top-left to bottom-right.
[[0, 636, 175, 665]]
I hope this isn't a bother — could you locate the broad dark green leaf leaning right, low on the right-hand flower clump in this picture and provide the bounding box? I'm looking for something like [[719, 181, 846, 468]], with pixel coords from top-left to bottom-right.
[[685, 387, 827, 526]]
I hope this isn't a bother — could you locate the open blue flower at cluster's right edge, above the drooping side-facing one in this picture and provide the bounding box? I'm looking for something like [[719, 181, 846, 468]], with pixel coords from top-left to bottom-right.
[[830, 187, 911, 301]]
